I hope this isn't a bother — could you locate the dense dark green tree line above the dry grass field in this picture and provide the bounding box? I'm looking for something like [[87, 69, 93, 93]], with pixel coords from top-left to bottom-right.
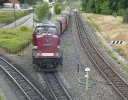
[[81, 0, 128, 22]]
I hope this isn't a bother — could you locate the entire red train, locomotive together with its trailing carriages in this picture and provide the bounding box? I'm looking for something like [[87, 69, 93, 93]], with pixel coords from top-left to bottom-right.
[[32, 8, 71, 71]]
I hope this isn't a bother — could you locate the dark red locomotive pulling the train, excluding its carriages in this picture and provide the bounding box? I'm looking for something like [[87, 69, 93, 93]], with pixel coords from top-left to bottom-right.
[[32, 25, 62, 71]]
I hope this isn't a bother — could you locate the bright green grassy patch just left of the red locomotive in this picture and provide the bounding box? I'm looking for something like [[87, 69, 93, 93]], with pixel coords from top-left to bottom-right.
[[0, 26, 33, 54]]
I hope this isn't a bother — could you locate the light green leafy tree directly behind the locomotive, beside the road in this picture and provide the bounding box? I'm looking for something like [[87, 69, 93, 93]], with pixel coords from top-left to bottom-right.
[[35, 2, 50, 23]]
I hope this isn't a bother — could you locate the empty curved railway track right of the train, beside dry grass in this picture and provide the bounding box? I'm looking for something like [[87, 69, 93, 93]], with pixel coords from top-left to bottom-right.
[[75, 12, 128, 100]]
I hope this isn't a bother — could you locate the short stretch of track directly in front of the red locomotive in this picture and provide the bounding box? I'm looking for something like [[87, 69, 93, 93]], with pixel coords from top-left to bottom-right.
[[43, 72, 72, 100]]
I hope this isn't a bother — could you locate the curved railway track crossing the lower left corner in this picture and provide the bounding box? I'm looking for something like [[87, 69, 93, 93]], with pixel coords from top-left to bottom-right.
[[0, 57, 46, 100]]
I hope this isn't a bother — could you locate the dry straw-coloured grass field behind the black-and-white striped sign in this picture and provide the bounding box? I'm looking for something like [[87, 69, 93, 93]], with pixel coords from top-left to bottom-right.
[[82, 13, 128, 60]]
